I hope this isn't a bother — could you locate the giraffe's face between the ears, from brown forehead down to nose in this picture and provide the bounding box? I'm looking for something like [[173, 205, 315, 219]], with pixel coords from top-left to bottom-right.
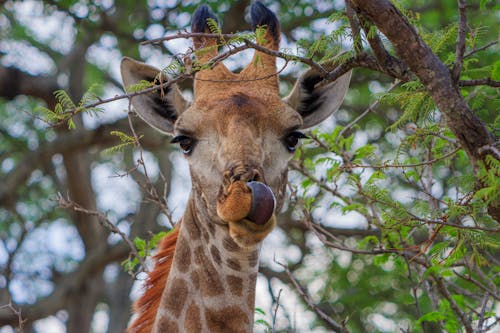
[[174, 91, 302, 224]]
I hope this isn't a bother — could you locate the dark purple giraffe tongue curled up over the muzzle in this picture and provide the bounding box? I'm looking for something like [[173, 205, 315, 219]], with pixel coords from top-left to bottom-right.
[[247, 181, 276, 225]]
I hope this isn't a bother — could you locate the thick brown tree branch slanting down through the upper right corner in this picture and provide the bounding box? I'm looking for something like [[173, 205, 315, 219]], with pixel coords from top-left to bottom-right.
[[352, 0, 493, 162]]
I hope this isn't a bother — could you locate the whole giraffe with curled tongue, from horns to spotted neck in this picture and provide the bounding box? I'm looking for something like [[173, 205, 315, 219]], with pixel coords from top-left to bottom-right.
[[121, 1, 351, 333]]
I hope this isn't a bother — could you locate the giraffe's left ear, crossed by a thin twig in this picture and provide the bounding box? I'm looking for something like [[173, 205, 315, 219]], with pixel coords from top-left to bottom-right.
[[120, 57, 189, 134]]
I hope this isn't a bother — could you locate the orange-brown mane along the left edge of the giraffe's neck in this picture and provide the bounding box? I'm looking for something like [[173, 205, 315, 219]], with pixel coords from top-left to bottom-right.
[[127, 223, 179, 333]]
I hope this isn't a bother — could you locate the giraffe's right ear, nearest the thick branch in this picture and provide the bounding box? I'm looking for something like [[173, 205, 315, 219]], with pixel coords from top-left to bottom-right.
[[283, 69, 351, 128]]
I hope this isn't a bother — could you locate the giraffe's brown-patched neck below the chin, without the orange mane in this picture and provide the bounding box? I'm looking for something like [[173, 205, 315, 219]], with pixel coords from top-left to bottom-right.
[[153, 197, 259, 333]]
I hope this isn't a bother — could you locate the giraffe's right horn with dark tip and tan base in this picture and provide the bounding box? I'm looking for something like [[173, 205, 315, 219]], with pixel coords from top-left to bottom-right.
[[241, 1, 280, 90]]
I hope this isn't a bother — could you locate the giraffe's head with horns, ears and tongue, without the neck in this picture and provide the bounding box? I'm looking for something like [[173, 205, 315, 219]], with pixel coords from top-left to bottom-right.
[[121, 2, 350, 246]]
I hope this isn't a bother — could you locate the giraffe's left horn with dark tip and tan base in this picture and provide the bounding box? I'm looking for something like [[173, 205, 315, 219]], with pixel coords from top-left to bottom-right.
[[191, 5, 230, 89]]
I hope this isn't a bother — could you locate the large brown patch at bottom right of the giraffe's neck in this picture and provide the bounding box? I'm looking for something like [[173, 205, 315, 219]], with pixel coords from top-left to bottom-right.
[[205, 306, 250, 332]]
